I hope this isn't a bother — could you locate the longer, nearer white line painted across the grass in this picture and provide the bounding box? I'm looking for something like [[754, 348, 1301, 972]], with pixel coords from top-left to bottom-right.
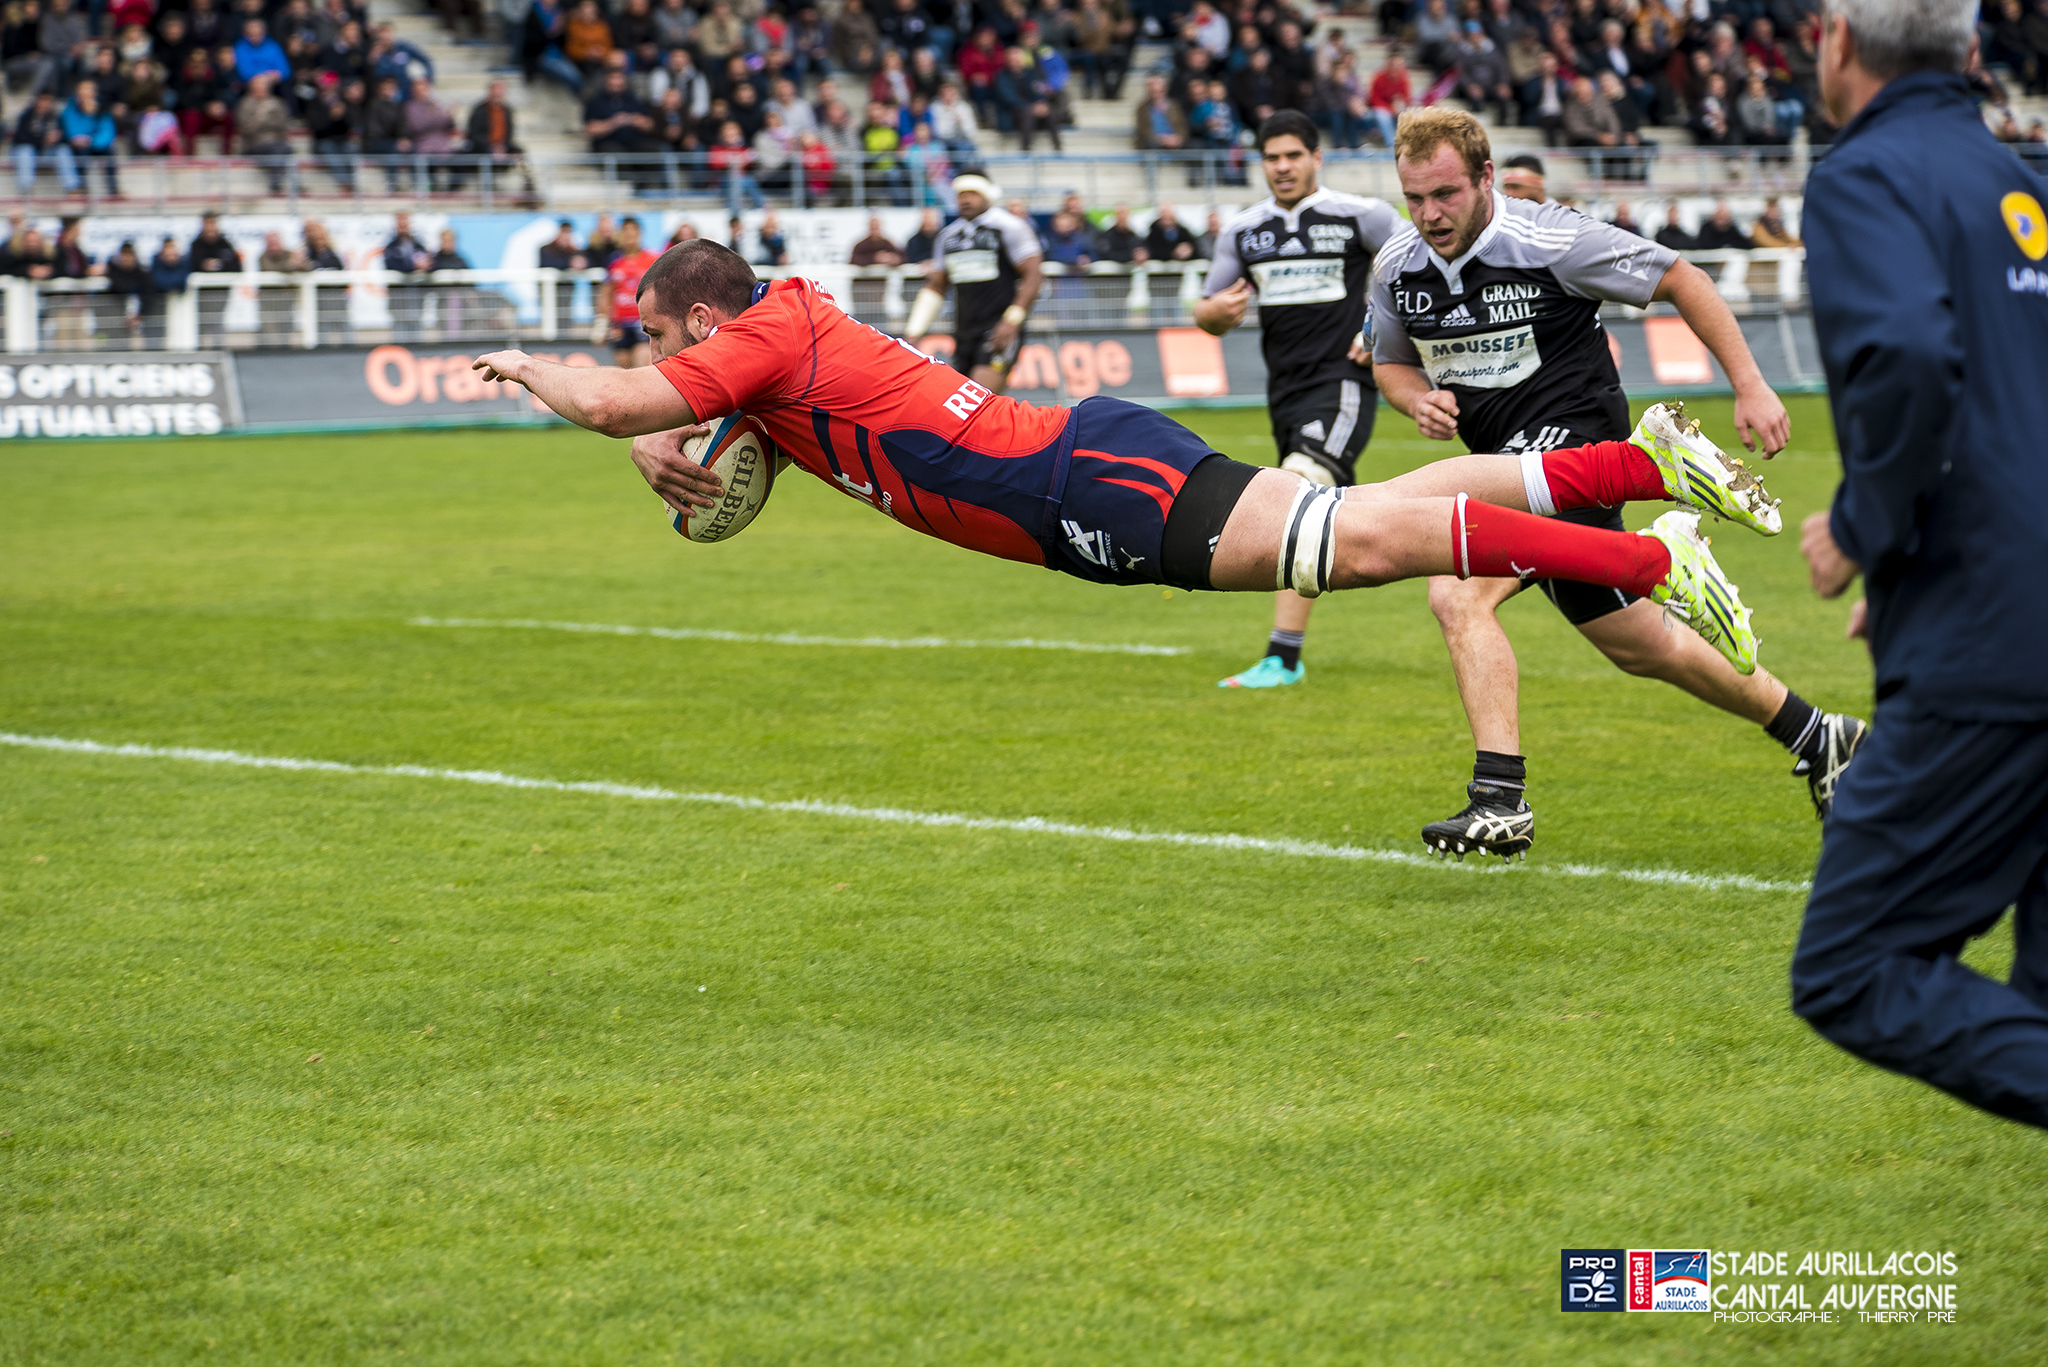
[[0, 732, 1806, 894]]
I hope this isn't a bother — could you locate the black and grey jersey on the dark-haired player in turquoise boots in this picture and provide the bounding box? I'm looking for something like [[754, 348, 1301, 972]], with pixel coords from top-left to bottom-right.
[[1202, 189, 1403, 404]]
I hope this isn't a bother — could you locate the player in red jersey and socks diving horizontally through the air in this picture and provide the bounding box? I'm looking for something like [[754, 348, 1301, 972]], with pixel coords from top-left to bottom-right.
[[475, 240, 1776, 827]]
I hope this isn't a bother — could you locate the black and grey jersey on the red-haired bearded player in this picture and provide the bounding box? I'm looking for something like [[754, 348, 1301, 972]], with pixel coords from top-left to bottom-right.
[[1372, 193, 1677, 451]]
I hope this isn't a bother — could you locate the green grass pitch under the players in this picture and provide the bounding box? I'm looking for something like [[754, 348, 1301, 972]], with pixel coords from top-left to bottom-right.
[[0, 400, 2048, 1365]]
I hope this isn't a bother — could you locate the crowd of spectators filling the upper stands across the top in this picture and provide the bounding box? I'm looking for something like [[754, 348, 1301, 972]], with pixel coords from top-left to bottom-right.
[[0, 0, 2048, 209]]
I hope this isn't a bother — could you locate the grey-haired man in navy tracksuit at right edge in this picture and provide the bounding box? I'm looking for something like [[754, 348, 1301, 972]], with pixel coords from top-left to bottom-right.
[[1792, 0, 2048, 1127]]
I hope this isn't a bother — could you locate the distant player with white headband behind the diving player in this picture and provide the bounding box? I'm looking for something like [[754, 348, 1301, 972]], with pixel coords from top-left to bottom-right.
[[905, 176, 1044, 393]]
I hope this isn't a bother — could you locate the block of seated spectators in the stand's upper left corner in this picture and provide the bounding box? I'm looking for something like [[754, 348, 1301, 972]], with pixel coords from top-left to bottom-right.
[[0, 0, 536, 197]]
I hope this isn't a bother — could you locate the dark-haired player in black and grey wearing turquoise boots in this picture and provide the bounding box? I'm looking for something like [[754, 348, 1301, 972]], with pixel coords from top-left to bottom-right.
[[1194, 109, 1401, 689]]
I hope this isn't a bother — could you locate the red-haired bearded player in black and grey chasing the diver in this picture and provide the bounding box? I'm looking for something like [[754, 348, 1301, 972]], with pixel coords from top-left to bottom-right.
[[1372, 107, 1864, 855]]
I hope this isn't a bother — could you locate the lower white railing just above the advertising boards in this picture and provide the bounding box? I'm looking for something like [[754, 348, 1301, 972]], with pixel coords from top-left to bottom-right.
[[0, 248, 1806, 355]]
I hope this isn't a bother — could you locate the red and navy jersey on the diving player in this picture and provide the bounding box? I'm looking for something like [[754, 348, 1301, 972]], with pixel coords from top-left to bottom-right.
[[657, 281, 1073, 566]]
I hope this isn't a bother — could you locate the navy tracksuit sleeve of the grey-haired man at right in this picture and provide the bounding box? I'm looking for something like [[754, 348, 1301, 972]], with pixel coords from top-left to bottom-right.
[[1804, 162, 1962, 572]]
